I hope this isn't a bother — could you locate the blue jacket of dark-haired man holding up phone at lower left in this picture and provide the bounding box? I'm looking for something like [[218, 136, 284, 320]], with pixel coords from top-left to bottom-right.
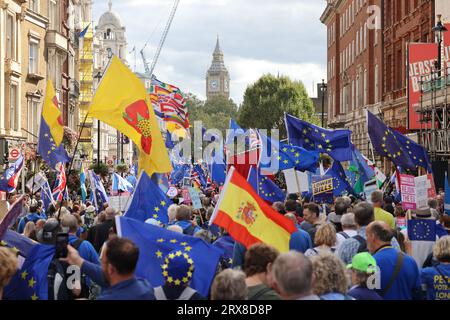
[[81, 261, 155, 300]]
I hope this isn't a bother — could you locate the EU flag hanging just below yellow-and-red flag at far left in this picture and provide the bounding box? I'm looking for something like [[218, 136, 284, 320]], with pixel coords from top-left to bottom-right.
[[38, 117, 70, 169]]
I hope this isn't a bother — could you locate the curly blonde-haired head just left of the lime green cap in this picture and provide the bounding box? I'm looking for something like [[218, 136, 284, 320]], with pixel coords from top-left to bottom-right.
[[311, 252, 354, 300]]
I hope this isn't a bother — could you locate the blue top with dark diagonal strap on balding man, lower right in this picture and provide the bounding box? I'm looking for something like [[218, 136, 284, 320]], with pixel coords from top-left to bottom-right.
[[373, 246, 421, 300]]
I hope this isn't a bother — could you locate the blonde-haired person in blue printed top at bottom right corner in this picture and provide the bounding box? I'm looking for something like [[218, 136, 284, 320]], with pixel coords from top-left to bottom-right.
[[420, 236, 450, 300]]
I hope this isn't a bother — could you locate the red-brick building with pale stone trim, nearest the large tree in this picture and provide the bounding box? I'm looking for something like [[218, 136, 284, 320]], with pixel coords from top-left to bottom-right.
[[320, 0, 383, 154]]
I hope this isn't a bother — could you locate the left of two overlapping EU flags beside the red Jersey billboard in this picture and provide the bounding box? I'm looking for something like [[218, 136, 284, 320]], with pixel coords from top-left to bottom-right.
[[367, 112, 416, 171]]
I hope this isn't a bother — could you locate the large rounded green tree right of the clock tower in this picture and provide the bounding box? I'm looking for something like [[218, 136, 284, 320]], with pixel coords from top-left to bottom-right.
[[239, 74, 319, 136]]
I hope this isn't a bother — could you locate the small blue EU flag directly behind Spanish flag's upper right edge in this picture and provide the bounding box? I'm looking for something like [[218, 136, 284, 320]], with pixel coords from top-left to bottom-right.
[[247, 166, 286, 203]]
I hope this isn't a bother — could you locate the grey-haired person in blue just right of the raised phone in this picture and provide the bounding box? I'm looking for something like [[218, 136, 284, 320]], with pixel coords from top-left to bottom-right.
[[61, 214, 100, 265]]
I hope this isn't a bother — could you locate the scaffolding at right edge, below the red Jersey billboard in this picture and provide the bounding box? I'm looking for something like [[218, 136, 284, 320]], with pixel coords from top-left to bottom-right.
[[415, 69, 450, 161]]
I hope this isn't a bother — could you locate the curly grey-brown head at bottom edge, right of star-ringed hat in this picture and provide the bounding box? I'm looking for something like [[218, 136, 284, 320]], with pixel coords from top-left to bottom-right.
[[211, 269, 248, 300]]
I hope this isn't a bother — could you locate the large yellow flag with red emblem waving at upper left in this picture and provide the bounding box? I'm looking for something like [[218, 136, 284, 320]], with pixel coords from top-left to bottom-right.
[[89, 56, 172, 176]]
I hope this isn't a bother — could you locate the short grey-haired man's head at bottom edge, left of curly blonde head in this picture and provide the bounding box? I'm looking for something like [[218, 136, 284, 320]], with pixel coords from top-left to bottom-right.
[[269, 251, 319, 300]]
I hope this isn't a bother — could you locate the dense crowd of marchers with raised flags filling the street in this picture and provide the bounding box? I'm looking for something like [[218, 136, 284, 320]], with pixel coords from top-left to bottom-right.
[[0, 57, 450, 300]]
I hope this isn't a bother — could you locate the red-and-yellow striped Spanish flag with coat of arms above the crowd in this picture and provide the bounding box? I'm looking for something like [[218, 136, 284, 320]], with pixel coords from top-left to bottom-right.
[[210, 167, 297, 252]]
